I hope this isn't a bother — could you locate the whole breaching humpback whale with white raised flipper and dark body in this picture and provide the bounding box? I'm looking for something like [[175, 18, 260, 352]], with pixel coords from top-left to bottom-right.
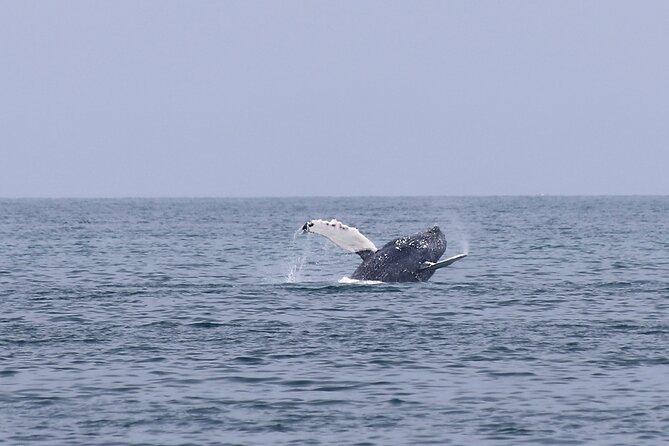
[[302, 219, 467, 282]]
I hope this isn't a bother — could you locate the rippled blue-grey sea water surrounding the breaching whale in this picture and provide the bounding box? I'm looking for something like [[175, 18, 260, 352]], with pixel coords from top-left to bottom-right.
[[0, 197, 669, 445]]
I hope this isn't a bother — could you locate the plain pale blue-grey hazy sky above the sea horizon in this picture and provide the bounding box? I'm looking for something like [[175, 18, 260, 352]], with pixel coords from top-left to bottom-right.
[[0, 0, 669, 198]]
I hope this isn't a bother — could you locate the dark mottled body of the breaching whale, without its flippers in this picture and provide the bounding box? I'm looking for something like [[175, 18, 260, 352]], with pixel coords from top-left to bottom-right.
[[351, 226, 446, 282]]
